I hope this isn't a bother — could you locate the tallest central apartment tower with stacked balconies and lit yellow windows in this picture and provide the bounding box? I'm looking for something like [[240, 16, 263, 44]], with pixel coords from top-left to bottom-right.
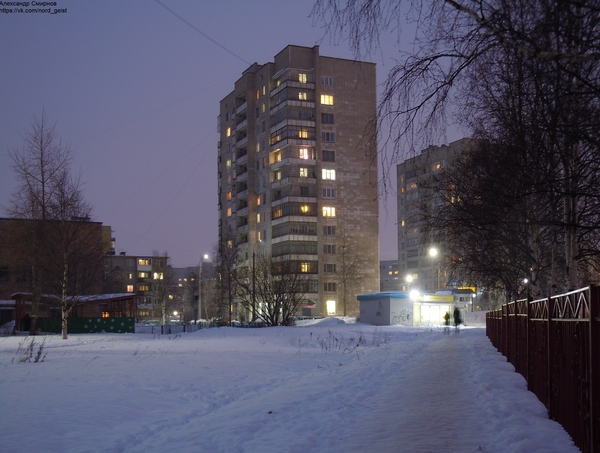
[[218, 45, 379, 318]]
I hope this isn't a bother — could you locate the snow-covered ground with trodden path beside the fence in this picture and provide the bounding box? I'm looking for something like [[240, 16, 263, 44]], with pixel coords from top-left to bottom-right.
[[0, 319, 579, 453]]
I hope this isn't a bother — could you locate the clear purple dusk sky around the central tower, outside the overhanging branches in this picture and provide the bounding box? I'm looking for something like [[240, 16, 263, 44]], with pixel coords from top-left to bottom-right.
[[0, 0, 460, 267]]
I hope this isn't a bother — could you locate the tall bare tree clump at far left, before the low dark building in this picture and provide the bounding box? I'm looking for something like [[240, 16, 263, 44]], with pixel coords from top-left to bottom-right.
[[6, 111, 95, 338]]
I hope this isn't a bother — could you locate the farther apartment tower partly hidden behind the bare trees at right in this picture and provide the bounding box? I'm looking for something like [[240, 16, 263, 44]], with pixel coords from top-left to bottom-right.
[[396, 138, 469, 292]]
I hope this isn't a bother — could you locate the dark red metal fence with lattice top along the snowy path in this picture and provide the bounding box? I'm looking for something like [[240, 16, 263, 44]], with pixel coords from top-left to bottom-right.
[[486, 286, 600, 453]]
